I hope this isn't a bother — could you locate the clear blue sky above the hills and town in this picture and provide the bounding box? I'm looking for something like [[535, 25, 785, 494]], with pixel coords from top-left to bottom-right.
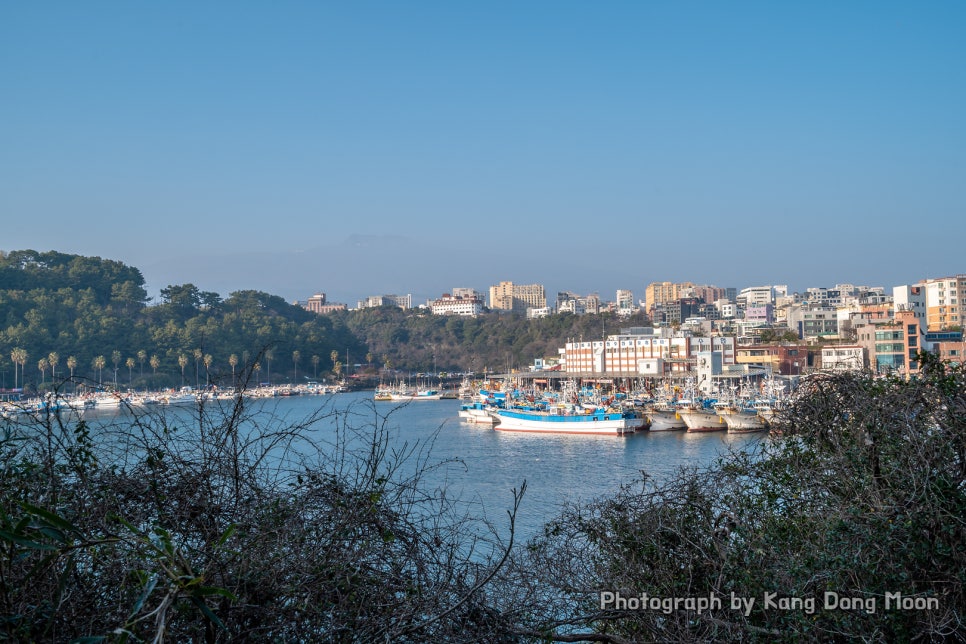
[[0, 0, 966, 305]]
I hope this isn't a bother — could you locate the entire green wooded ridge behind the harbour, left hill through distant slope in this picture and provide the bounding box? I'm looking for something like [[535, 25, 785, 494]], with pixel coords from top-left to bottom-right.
[[0, 250, 645, 388]]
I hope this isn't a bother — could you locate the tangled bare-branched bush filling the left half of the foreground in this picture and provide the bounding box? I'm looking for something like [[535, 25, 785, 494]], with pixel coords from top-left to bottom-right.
[[0, 374, 522, 642]]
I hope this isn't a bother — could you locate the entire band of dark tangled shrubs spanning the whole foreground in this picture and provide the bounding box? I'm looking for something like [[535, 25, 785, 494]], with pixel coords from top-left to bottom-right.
[[0, 356, 966, 642]]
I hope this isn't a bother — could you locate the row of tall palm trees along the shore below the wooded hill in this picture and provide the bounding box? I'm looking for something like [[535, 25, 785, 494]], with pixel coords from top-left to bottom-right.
[[10, 347, 350, 389]]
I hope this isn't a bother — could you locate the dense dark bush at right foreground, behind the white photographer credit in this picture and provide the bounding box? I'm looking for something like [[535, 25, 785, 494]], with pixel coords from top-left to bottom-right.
[[510, 356, 966, 642]]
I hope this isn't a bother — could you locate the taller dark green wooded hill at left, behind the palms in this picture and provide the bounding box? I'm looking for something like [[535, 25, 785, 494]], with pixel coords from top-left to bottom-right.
[[0, 250, 363, 387]]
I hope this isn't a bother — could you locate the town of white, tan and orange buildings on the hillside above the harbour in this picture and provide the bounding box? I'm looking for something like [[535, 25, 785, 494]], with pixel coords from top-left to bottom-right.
[[298, 274, 966, 387]]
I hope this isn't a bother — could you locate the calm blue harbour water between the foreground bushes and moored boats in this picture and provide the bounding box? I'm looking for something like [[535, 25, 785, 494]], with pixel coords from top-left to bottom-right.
[[73, 392, 761, 536]]
